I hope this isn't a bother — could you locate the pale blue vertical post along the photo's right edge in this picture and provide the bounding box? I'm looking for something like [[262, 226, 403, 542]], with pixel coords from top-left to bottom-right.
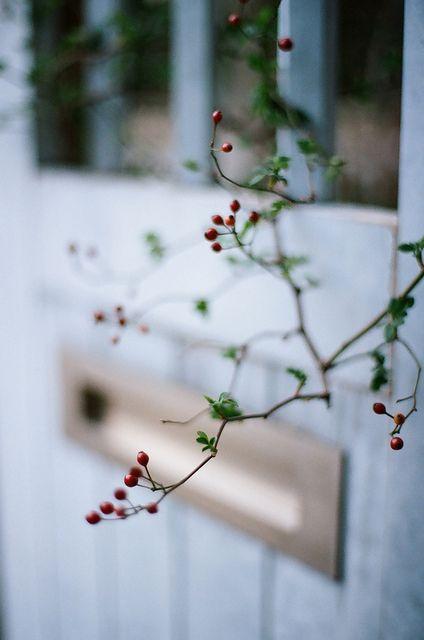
[[381, 0, 424, 640]]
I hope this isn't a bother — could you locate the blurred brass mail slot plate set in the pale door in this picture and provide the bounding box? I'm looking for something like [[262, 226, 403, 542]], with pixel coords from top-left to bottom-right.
[[63, 351, 342, 578]]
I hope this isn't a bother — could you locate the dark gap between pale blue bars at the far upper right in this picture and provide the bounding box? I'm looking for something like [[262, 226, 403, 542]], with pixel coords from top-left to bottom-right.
[[336, 0, 403, 207]]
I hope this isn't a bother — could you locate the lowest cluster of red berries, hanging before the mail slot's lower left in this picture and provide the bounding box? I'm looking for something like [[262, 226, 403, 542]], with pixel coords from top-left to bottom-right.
[[85, 451, 159, 524]]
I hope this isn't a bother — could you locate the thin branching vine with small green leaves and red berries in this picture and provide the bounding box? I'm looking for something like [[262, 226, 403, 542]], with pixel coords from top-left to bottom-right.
[[1, 0, 418, 524]]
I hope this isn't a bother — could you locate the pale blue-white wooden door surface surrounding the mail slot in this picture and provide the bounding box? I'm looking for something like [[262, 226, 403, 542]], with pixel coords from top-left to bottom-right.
[[0, 0, 424, 640]]
